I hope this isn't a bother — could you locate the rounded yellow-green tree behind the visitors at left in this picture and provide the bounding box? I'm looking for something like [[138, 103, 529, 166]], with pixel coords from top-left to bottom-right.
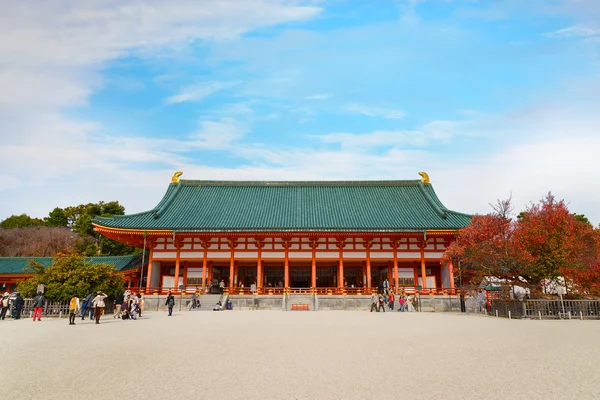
[[17, 254, 124, 301]]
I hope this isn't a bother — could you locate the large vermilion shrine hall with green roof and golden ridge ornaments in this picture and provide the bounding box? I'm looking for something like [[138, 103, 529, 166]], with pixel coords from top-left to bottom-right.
[[93, 172, 471, 295]]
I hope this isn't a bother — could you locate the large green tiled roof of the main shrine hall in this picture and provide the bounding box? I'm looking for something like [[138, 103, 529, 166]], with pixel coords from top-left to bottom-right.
[[93, 180, 471, 232]]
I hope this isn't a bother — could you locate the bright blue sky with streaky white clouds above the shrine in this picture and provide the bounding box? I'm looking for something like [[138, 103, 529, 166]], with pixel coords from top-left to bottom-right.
[[0, 0, 600, 224]]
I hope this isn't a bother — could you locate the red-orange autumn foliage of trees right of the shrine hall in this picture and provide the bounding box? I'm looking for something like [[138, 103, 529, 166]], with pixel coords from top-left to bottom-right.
[[444, 193, 600, 294]]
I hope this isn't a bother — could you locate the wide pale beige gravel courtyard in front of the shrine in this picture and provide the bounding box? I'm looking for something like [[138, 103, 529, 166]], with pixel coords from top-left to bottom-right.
[[0, 311, 600, 400]]
